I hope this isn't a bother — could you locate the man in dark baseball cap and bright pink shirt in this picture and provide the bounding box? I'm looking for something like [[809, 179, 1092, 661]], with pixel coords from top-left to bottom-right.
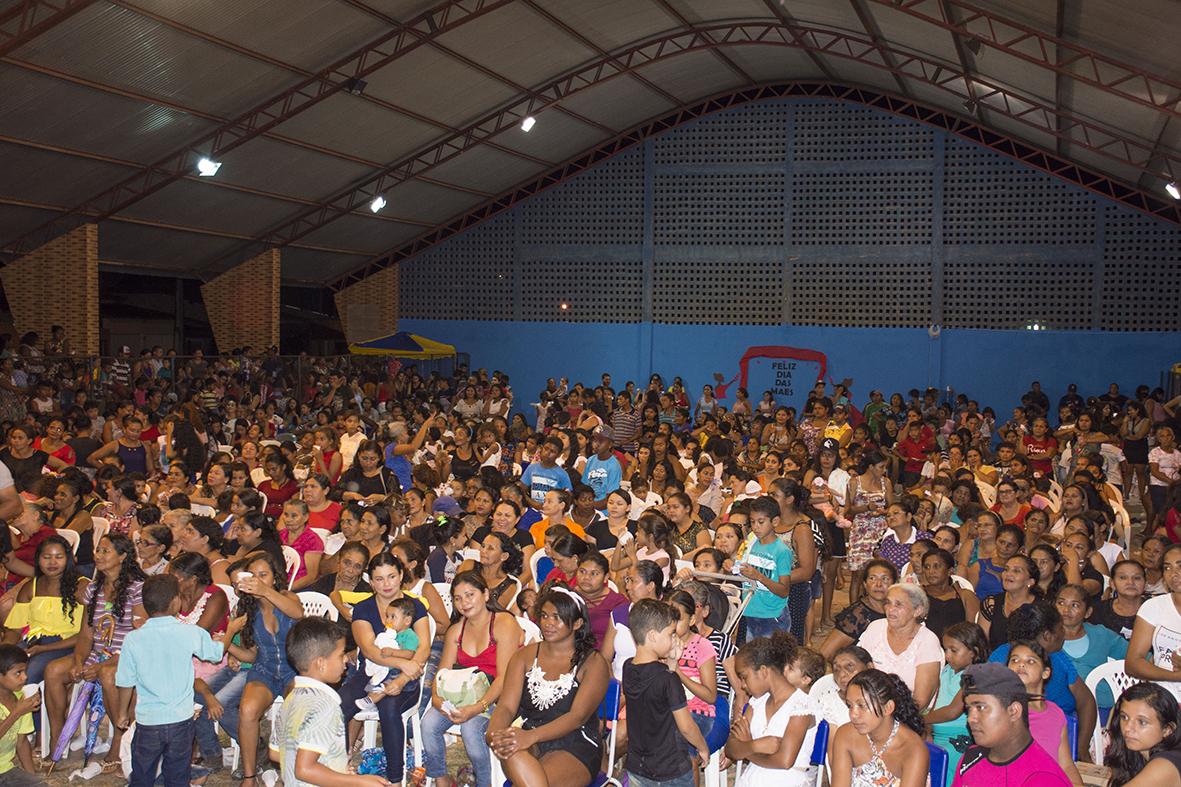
[[952, 663, 1070, 787]]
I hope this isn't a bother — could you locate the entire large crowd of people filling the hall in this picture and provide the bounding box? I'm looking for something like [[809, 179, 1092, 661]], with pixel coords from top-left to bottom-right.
[[0, 337, 1181, 787]]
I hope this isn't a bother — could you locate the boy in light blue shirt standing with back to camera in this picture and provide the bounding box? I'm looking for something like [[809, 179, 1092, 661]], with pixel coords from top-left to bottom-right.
[[115, 574, 222, 787]]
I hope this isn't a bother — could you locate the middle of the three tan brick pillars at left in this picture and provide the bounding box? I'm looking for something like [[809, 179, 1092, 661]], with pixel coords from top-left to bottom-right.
[[201, 249, 280, 352]]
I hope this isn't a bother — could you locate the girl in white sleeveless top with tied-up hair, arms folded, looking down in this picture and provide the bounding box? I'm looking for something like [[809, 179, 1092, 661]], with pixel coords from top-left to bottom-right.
[[726, 631, 817, 787]]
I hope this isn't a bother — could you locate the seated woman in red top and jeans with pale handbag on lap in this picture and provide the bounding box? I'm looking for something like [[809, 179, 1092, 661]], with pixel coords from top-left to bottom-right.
[[423, 571, 523, 787]]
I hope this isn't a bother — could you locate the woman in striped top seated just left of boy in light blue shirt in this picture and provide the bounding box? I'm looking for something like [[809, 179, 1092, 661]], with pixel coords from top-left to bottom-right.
[[45, 534, 148, 770]]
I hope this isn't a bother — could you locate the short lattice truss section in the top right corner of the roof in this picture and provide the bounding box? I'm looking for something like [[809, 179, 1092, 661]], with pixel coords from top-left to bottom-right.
[[868, 0, 1181, 115]]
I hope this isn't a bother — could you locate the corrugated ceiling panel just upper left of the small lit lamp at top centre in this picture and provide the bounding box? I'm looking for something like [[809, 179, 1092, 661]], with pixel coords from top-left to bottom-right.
[[365, 46, 516, 128]]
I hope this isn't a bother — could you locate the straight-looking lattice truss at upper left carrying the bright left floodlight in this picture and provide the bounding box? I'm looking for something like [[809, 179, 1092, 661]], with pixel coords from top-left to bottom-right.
[[0, 0, 514, 259]]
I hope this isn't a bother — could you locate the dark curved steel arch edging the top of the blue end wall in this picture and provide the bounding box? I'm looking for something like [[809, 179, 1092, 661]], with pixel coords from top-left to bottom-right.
[[331, 82, 1181, 291]]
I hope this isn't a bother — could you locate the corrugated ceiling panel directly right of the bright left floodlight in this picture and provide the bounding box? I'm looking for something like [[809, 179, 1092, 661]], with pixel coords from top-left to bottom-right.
[[217, 137, 371, 205]]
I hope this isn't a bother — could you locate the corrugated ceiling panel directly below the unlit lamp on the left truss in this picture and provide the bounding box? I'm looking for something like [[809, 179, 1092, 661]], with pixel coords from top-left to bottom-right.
[[279, 93, 441, 162]]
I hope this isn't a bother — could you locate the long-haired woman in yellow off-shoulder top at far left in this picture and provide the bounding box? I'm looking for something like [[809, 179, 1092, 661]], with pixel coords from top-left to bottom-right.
[[4, 535, 90, 683]]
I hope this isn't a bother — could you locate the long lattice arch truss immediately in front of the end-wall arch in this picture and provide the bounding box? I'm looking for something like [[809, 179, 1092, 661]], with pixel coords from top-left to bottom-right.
[[210, 20, 1181, 269]]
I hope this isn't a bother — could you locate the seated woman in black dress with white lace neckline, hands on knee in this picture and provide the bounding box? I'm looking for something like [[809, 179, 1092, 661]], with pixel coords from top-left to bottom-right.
[[487, 587, 611, 785]]
